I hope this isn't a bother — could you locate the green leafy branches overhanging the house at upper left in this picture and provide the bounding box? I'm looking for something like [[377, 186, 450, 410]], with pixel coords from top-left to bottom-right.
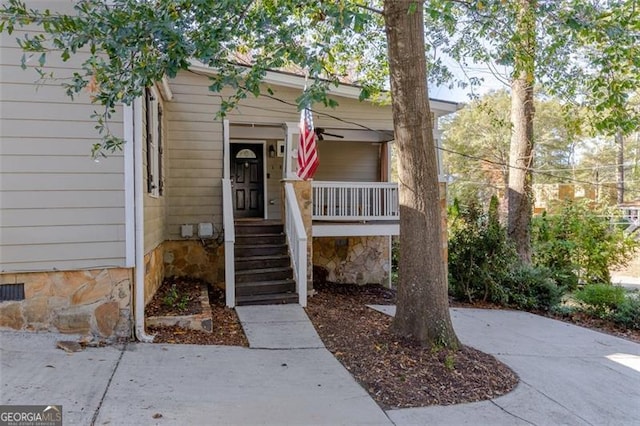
[[0, 0, 386, 152]]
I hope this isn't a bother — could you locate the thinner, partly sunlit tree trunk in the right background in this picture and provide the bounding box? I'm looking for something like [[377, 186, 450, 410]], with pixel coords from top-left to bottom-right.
[[507, 0, 536, 263]]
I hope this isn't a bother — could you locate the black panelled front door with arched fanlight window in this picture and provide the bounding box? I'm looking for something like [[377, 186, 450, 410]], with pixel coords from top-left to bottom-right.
[[231, 143, 264, 218]]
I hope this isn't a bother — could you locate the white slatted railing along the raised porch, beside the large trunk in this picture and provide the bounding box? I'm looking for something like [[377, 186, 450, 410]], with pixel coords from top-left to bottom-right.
[[311, 181, 400, 221]]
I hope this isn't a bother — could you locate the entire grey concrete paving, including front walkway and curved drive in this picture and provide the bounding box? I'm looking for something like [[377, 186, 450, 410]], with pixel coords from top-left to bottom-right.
[[0, 306, 640, 425]]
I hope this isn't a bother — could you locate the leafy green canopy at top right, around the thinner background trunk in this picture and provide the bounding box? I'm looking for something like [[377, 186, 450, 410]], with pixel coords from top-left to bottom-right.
[[426, 0, 640, 134]]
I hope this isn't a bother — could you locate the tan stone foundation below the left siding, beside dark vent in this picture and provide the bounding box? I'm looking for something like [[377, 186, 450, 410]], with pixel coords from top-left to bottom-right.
[[0, 268, 133, 337]]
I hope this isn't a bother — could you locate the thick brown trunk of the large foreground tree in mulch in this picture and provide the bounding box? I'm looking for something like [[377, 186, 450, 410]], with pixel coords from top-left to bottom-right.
[[384, 0, 460, 349]]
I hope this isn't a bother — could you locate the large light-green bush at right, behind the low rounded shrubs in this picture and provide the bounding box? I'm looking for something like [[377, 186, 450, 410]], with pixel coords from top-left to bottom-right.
[[532, 201, 640, 290]]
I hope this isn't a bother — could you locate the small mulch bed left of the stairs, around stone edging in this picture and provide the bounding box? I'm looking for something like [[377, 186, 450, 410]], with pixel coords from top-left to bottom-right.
[[145, 278, 249, 347]]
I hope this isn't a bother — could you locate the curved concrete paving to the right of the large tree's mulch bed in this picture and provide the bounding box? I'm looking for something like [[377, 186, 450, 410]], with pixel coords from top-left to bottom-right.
[[370, 306, 640, 425]]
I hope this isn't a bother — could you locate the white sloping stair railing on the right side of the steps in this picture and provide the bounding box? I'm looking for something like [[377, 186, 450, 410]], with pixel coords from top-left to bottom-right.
[[284, 183, 307, 308]]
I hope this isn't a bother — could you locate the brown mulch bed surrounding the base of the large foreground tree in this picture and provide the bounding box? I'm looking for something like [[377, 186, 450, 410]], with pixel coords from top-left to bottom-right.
[[307, 283, 518, 409]]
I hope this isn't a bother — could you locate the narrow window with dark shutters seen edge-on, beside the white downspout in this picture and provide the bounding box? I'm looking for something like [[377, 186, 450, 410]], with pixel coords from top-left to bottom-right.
[[145, 88, 164, 197]]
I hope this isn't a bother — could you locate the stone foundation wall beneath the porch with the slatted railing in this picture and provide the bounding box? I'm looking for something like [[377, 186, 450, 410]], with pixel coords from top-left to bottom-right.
[[313, 237, 391, 286]]
